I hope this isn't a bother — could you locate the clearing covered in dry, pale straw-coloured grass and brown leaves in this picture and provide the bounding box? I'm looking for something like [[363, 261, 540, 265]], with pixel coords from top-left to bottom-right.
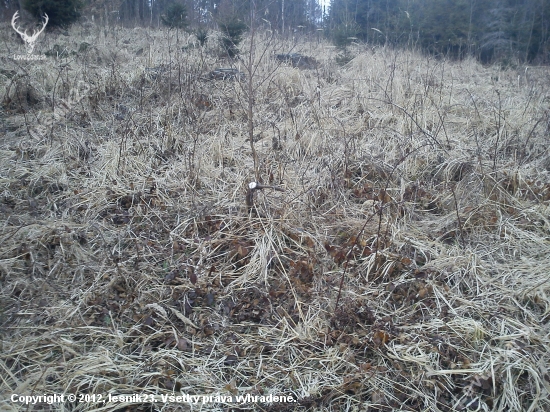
[[0, 26, 550, 411]]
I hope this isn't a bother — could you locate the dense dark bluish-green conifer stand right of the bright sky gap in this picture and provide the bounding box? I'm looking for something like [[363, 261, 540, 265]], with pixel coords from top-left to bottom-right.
[[325, 0, 550, 63]]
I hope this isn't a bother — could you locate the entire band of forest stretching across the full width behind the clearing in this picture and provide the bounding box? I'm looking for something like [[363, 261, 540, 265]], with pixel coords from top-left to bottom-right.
[[0, 0, 550, 64]]
